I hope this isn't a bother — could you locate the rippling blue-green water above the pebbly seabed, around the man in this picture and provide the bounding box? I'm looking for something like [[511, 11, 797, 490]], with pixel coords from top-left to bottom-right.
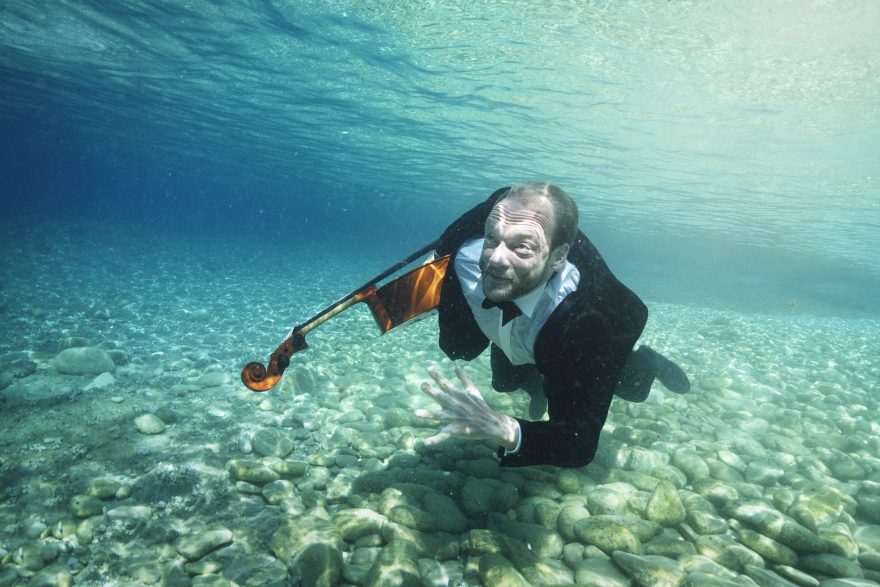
[[0, 1, 880, 314]]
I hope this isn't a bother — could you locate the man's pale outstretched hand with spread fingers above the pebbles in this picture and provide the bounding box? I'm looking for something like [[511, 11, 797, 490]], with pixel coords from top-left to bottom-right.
[[415, 366, 519, 449]]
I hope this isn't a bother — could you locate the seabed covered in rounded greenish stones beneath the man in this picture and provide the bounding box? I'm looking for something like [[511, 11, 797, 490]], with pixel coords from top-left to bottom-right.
[[0, 268, 880, 587]]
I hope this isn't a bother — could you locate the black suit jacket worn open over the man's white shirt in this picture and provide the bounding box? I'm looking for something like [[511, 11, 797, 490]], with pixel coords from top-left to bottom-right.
[[437, 188, 648, 467]]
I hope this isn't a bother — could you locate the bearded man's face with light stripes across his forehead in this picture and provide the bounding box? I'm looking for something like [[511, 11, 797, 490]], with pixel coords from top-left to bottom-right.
[[480, 198, 568, 302]]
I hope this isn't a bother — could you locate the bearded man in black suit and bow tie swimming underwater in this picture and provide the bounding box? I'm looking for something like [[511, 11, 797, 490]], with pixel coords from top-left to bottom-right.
[[416, 183, 690, 467]]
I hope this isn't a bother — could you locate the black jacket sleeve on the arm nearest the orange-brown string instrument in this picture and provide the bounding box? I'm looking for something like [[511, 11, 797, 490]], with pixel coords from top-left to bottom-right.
[[437, 188, 510, 361]]
